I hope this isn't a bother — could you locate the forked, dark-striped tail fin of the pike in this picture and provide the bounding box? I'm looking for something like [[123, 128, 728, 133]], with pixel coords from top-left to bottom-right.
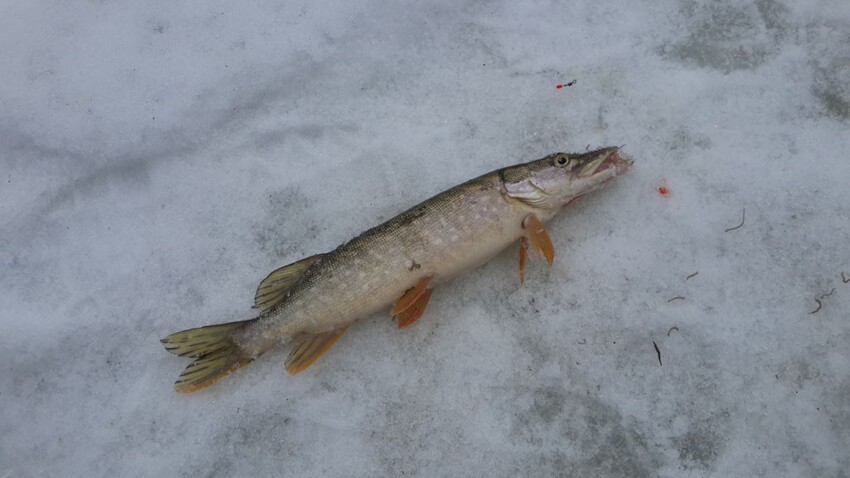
[[161, 319, 257, 393]]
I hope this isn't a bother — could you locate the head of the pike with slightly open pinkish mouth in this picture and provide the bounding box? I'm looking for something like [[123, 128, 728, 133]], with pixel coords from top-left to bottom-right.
[[499, 146, 632, 213]]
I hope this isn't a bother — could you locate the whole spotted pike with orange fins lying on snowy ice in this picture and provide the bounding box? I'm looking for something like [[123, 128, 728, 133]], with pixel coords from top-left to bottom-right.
[[161, 147, 633, 393]]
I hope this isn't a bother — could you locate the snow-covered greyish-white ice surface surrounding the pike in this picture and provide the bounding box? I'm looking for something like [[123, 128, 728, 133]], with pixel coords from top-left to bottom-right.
[[0, 0, 850, 477]]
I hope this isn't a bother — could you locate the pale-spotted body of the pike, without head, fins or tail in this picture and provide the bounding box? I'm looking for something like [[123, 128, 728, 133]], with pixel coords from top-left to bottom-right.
[[246, 173, 528, 337]]
